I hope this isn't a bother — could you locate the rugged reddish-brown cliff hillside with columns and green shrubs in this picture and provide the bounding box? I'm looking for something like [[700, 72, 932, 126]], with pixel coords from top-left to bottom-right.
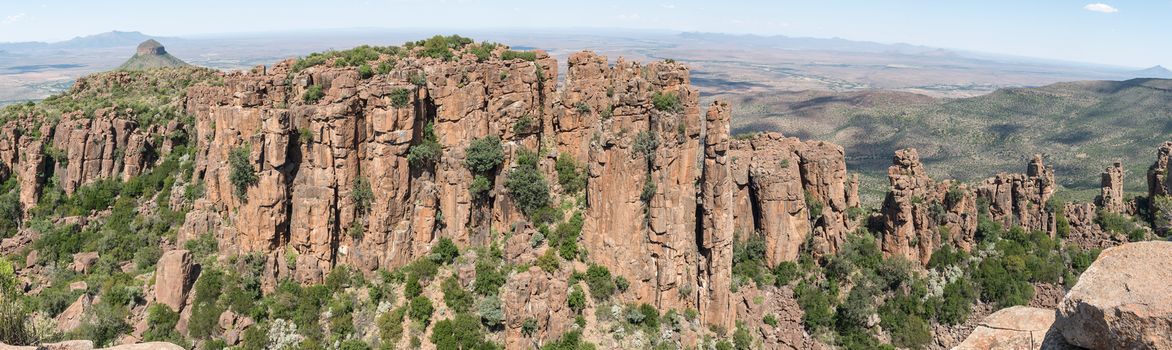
[[0, 35, 1172, 350]]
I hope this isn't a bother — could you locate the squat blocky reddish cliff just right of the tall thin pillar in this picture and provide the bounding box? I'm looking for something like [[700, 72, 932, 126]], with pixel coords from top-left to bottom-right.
[[729, 133, 858, 265]]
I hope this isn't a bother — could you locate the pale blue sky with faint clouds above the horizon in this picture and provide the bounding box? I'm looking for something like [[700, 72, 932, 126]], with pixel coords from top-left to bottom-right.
[[0, 0, 1172, 68]]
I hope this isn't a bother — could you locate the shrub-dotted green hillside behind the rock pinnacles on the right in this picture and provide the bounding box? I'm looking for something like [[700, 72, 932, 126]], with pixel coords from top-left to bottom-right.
[[729, 80, 1172, 200]]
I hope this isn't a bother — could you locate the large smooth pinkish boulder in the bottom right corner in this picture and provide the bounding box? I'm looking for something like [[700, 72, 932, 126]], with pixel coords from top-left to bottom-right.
[[1055, 241, 1172, 349]]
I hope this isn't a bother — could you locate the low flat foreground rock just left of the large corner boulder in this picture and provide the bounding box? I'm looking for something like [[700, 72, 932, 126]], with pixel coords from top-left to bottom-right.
[[953, 307, 1072, 350]]
